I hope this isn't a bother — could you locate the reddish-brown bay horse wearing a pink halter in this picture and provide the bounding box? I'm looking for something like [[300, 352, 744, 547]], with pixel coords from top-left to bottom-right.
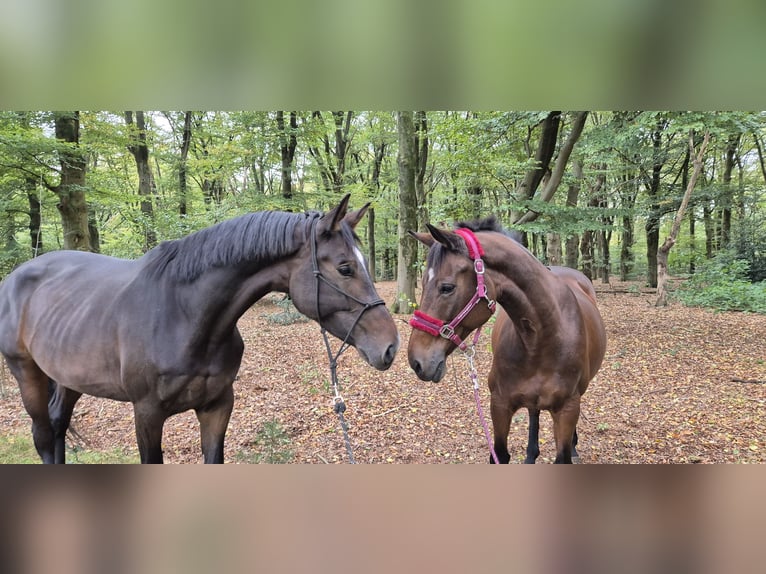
[[408, 217, 606, 463]]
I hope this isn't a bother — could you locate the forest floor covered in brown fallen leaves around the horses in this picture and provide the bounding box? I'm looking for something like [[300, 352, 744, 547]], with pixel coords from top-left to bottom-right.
[[0, 281, 766, 464]]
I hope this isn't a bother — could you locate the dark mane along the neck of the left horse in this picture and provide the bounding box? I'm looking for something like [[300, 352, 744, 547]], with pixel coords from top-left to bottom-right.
[[143, 211, 321, 283]]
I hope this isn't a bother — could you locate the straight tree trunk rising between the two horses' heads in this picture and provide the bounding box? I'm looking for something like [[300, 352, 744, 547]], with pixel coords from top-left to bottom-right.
[[392, 112, 418, 313]]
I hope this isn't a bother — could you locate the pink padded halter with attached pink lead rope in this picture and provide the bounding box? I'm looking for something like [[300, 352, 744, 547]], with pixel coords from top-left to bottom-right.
[[410, 227, 499, 464]]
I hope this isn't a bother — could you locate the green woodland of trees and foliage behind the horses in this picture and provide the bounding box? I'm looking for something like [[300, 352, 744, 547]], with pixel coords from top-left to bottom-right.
[[0, 110, 766, 318]]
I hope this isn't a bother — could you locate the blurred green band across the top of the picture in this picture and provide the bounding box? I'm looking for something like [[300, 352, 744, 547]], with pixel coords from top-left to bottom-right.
[[0, 0, 766, 109]]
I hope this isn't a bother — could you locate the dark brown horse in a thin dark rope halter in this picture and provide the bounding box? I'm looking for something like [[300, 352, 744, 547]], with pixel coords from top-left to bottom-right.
[[0, 195, 399, 463]]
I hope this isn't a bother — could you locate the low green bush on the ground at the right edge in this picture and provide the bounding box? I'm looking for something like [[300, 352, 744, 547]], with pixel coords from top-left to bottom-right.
[[675, 251, 766, 314]]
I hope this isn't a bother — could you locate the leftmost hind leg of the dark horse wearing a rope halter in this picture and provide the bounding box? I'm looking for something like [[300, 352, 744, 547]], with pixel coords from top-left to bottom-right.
[[6, 357, 55, 464]]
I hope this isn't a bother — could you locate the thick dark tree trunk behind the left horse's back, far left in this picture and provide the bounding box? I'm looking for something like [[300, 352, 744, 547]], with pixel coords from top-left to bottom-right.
[[51, 112, 91, 251]]
